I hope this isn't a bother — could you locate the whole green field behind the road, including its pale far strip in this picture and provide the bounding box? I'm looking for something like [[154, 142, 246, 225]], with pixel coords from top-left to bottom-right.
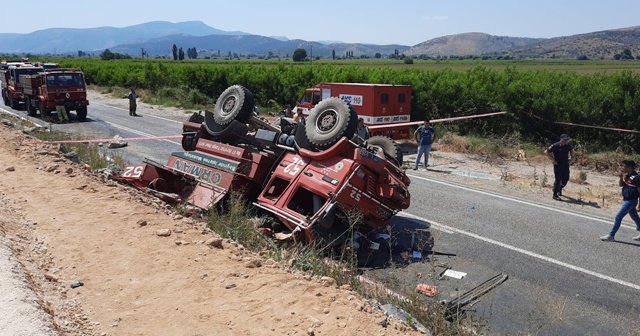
[[21, 58, 640, 152]]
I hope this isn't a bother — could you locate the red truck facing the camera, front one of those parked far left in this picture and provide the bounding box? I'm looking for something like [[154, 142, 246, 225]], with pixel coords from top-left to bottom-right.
[[20, 68, 89, 121]]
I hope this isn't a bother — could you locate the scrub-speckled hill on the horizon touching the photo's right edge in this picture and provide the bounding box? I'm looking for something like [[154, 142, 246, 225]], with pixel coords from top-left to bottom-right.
[[508, 26, 640, 59]]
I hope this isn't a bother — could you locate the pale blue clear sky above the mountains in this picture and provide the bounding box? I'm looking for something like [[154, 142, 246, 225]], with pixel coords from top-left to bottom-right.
[[8, 0, 640, 45]]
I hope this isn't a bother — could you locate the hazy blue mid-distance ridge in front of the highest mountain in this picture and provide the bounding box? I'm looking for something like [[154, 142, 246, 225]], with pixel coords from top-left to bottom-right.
[[102, 34, 409, 57]]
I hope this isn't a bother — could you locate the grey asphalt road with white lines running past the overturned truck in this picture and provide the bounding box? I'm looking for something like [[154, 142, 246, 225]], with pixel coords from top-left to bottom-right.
[[4, 104, 640, 335]]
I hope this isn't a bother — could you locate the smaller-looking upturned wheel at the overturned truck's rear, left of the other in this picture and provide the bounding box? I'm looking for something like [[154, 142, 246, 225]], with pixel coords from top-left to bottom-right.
[[213, 85, 255, 125]]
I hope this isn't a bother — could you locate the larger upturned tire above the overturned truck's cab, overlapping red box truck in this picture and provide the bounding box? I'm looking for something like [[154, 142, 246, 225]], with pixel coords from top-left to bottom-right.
[[305, 97, 358, 150]]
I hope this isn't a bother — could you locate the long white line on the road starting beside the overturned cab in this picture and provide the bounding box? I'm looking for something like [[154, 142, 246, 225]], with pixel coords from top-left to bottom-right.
[[400, 211, 640, 290]]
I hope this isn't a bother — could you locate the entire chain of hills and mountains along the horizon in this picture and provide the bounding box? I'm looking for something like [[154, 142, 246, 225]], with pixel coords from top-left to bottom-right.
[[5, 21, 640, 59]]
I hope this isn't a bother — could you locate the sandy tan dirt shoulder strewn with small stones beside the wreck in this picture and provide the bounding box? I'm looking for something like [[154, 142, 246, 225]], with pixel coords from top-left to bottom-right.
[[0, 125, 416, 335]]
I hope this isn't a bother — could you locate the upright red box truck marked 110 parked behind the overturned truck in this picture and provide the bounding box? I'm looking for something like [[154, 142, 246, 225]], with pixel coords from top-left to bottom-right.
[[294, 83, 412, 139]]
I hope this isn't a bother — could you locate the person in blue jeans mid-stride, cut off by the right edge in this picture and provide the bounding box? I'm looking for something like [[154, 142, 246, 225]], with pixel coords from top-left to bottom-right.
[[600, 160, 640, 241]]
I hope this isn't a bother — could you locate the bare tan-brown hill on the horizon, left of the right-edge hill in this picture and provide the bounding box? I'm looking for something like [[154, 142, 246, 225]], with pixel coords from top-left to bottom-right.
[[405, 33, 546, 57]]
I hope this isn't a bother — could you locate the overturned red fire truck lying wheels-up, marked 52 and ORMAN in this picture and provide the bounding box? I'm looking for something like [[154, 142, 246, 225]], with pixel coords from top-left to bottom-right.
[[113, 85, 411, 245]]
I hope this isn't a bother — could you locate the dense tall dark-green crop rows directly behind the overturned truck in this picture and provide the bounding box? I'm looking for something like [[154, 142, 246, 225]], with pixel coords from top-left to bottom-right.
[[61, 59, 640, 151]]
